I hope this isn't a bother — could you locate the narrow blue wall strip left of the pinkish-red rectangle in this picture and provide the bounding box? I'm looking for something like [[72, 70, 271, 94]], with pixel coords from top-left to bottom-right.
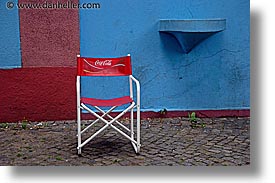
[[0, 1, 21, 69]]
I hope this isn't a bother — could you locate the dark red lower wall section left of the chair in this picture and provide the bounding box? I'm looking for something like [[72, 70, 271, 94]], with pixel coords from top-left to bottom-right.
[[0, 67, 76, 122]]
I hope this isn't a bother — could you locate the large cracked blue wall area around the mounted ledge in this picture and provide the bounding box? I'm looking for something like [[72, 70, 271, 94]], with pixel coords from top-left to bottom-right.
[[80, 0, 250, 111]]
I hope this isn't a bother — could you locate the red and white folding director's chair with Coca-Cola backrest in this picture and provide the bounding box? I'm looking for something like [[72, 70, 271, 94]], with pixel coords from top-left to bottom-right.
[[76, 54, 141, 154]]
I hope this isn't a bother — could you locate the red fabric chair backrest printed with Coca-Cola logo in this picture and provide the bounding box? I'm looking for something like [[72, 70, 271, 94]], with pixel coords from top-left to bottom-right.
[[77, 56, 132, 76]]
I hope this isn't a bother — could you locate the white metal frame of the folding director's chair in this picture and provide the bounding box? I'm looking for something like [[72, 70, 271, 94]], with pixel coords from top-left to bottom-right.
[[76, 54, 141, 154]]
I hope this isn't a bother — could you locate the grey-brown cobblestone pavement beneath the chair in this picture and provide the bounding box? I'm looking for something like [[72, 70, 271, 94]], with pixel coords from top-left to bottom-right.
[[0, 118, 250, 166]]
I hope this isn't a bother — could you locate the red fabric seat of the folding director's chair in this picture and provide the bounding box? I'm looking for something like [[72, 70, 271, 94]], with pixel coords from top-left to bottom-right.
[[81, 96, 133, 107]]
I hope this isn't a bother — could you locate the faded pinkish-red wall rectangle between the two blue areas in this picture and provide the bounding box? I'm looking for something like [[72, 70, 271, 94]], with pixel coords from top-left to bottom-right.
[[19, 0, 79, 67]]
